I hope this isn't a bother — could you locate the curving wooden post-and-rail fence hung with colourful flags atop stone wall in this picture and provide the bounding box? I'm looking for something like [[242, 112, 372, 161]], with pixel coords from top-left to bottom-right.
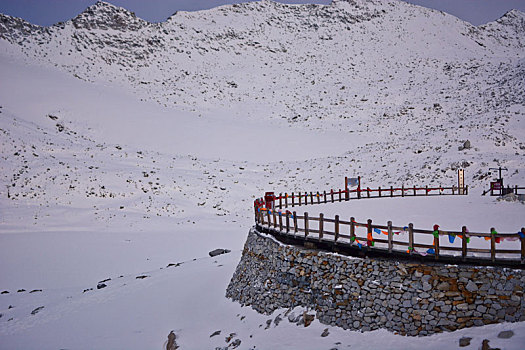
[[255, 186, 525, 268]]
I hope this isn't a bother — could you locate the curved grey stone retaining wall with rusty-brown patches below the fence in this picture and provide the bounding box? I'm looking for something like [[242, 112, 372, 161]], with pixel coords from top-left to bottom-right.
[[226, 229, 525, 336]]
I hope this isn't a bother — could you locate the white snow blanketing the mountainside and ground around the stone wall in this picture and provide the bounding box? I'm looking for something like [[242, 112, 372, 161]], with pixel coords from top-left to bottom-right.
[[0, 1, 525, 349]]
